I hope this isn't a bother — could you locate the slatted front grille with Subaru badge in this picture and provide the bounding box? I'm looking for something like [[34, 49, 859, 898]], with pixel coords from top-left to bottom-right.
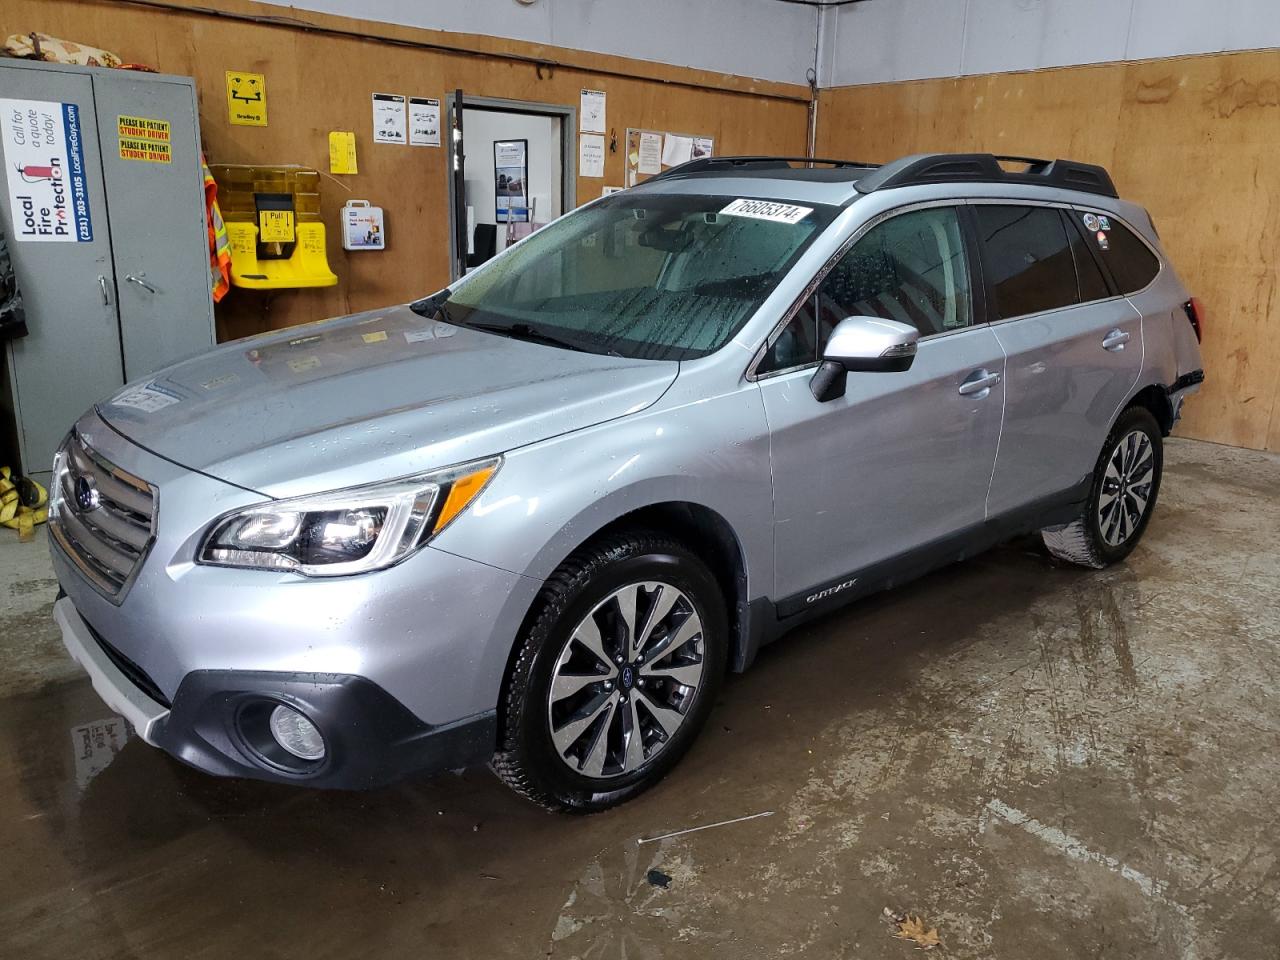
[[49, 433, 156, 602]]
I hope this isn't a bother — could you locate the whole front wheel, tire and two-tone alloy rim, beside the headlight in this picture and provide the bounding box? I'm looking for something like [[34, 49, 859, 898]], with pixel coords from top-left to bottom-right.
[[493, 531, 728, 813]]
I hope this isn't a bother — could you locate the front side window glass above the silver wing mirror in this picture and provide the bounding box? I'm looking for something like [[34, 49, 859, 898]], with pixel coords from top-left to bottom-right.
[[758, 207, 973, 374]]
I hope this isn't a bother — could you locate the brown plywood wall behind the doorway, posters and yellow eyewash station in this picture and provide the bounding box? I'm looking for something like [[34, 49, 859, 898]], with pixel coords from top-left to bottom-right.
[[0, 0, 808, 339]]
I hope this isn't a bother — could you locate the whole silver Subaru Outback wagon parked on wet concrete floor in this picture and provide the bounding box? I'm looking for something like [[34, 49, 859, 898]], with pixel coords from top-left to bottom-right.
[[50, 155, 1203, 812]]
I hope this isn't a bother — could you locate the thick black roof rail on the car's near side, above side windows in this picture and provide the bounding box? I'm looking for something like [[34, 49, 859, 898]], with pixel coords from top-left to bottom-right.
[[854, 154, 1119, 197]]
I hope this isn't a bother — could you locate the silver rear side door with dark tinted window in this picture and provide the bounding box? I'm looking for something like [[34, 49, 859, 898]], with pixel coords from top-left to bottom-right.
[[973, 204, 1155, 516]]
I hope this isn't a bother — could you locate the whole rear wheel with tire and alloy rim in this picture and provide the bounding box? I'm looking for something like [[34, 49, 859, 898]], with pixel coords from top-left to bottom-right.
[[1041, 407, 1165, 570]]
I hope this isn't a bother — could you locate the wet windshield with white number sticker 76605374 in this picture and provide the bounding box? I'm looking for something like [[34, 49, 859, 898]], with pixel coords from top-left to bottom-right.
[[440, 193, 836, 360]]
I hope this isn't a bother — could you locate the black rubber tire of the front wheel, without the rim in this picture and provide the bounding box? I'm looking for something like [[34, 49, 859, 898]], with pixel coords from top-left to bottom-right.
[[490, 530, 728, 813]]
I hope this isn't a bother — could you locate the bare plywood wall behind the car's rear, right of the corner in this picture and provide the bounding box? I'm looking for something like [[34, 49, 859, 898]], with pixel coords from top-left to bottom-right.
[[817, 51, 1280, 451]]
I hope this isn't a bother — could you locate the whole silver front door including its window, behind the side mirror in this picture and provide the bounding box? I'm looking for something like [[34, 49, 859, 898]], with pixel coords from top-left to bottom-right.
[[756, 206, 1004, 612]]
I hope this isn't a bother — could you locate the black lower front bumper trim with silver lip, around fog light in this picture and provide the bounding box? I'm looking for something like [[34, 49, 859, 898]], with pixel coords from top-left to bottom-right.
[[54, 596, 497, 790]]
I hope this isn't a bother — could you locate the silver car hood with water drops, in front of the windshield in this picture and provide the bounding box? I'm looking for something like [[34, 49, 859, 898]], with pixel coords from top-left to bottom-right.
[[97, 306, 680, 497]]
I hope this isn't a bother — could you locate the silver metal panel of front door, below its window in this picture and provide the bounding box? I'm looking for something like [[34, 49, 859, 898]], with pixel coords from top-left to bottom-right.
[[760, 325, 1005, 598]]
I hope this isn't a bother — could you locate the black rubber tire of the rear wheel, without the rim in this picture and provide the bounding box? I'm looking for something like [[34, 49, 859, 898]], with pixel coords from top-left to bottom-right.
[[1041, 407, 1165, 570]]
